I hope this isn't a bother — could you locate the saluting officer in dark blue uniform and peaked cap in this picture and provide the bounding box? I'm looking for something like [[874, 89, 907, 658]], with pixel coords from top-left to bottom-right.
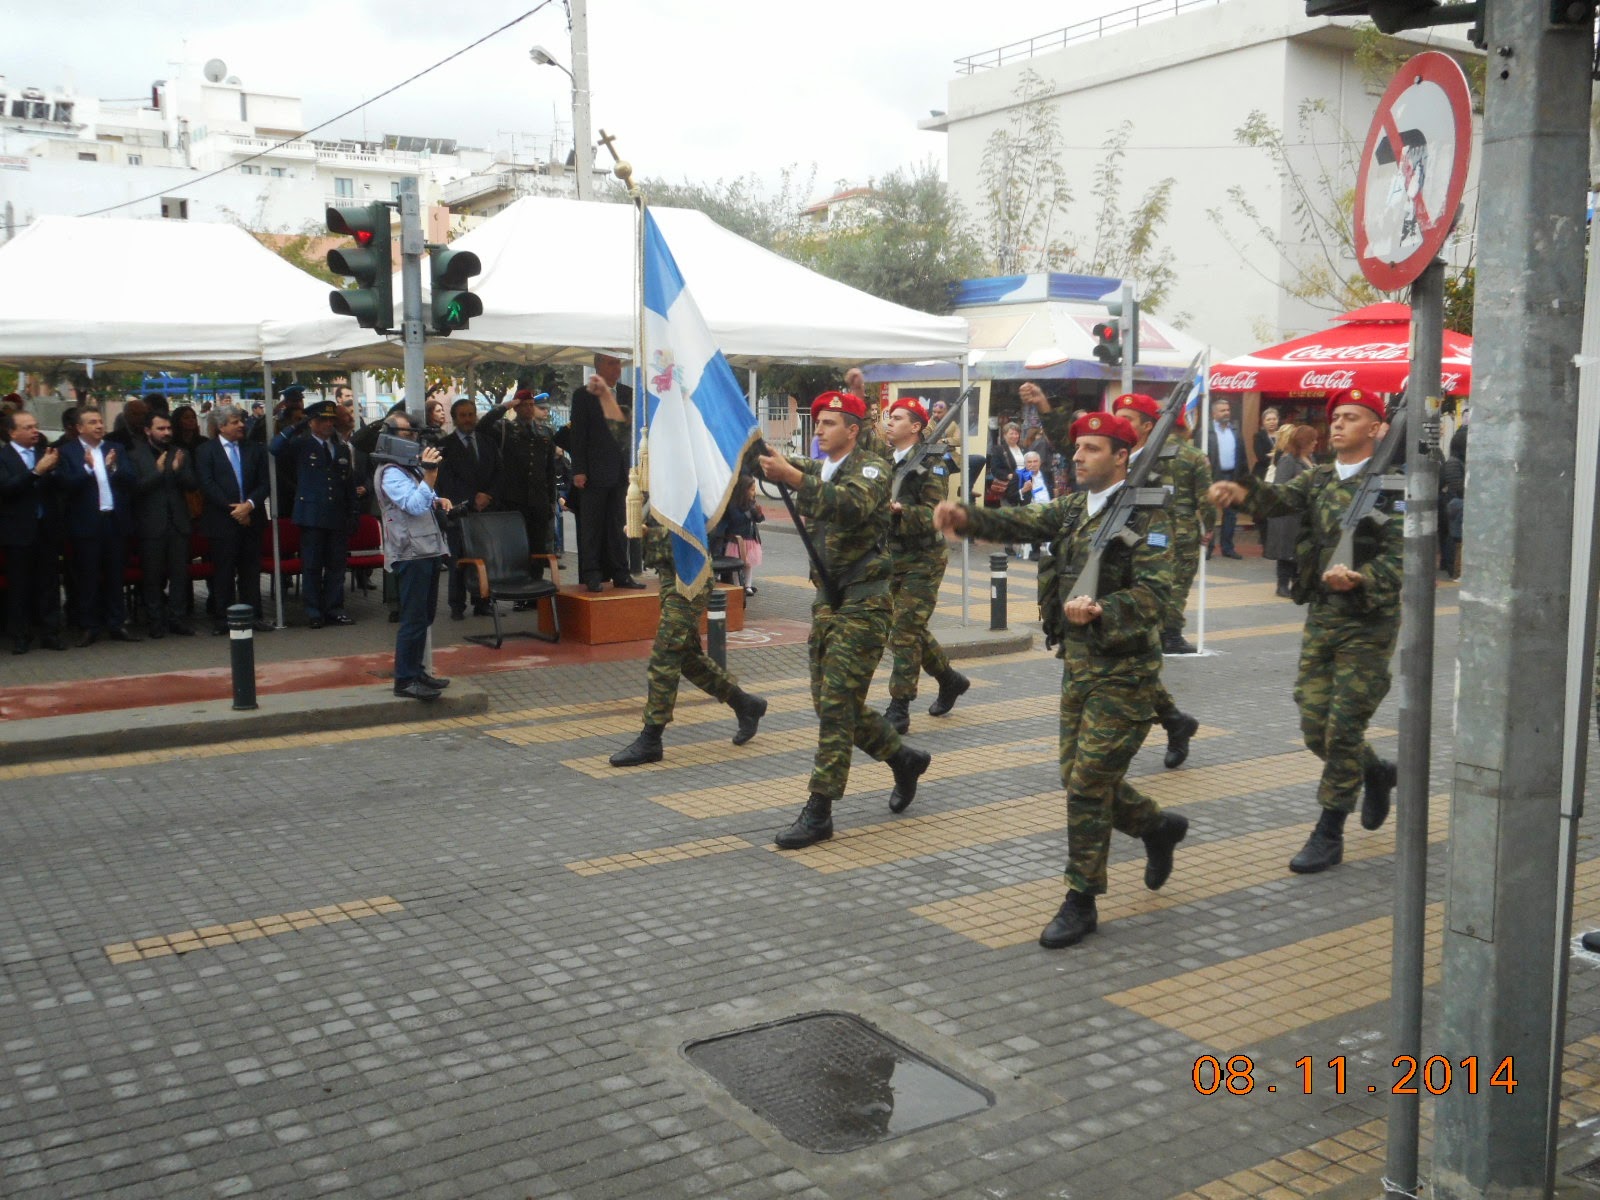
[[270, 400, 362, 629]]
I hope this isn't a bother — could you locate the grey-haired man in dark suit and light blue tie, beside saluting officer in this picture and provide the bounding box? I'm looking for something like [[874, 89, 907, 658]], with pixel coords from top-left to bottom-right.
[[195, 405, 272, 634]]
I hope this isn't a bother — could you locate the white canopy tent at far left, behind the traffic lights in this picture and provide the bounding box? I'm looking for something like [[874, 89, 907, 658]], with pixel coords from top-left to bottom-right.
[[0, 216, 328, 370]]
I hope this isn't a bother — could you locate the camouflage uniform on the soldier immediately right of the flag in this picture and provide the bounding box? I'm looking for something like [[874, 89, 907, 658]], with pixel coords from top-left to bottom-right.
[[789, 450, 901, 800]]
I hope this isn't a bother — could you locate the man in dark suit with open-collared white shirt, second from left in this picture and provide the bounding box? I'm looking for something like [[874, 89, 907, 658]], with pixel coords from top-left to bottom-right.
[[58, 408, 141, 646]]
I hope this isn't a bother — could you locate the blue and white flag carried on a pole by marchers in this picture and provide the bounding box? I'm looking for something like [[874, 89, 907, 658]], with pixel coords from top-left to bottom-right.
[[645, 211, 760, 595]]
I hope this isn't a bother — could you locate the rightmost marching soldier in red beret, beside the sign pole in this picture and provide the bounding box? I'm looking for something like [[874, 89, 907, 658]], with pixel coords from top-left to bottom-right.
[[1210, 387, 1405, 875]]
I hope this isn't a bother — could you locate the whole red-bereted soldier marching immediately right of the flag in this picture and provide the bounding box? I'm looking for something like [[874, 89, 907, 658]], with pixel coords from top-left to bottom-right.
[[758, 392, 930, 850]]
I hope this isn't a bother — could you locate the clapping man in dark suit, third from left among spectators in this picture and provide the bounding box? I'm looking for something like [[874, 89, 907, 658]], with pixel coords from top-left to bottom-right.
[[128, 413, 198, 638]]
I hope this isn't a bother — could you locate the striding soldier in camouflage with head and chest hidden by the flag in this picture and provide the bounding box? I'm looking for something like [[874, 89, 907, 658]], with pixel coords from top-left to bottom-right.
[[611, 520, 766, 766]]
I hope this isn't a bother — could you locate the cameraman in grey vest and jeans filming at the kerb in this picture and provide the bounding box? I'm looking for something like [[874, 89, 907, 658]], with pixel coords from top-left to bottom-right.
[[374, 413, 451, 701]]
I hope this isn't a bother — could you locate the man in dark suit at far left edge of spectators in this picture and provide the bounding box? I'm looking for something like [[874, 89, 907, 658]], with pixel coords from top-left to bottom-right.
[[0, 413, 67, 654]]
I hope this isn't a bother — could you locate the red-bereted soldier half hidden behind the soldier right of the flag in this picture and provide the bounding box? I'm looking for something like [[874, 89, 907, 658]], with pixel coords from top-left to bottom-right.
[[883, 397, 973, 733]]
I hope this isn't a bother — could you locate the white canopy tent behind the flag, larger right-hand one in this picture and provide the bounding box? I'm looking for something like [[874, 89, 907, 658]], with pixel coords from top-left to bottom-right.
[[267, 197, 966, 366]]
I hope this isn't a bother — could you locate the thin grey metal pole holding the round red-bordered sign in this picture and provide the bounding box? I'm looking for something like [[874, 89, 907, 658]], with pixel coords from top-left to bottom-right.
[[1384, 261, 1445, 1195]]
